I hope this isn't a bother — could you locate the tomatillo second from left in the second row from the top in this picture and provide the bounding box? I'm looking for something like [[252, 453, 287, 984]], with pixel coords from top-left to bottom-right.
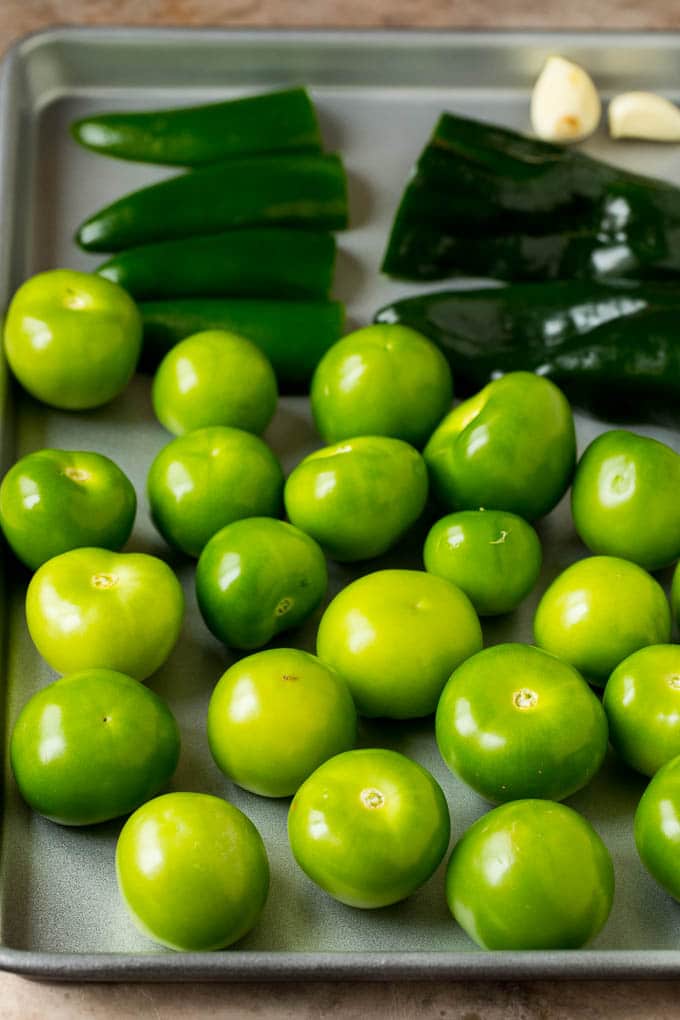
[[147, 425, 283, 557]]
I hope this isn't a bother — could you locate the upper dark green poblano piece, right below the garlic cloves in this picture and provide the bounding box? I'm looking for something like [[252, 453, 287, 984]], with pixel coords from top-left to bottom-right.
[[382, 113, 680, 281]]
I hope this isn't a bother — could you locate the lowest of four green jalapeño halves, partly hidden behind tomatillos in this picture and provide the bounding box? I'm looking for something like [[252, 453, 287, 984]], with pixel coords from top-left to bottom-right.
[[140, 298, 345, 392]]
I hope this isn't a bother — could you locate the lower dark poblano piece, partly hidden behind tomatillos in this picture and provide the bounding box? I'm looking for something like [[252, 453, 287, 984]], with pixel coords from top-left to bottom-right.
[[375, 281, 680, 420]]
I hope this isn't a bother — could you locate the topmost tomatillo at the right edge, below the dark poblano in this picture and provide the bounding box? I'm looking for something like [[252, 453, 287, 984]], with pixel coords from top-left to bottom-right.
[[571, 428, 680, 570]]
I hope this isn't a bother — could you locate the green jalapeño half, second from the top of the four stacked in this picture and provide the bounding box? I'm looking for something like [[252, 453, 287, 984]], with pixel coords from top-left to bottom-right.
[[75, 153, 348, 252]]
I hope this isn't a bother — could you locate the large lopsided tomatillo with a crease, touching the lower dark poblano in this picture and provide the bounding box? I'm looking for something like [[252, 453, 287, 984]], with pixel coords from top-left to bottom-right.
[[423, 372, 576, 520]]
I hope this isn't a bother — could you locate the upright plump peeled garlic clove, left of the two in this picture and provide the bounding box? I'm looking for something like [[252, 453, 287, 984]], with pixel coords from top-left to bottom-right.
[[531, 56, 601, 142]]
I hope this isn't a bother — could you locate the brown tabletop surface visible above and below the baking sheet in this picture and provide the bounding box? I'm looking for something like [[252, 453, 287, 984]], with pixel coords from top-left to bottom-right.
[[0, 0, 680, 1020]]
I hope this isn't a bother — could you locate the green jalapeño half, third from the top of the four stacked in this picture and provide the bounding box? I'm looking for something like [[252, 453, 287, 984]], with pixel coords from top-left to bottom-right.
[[97, 228, 335, 301]]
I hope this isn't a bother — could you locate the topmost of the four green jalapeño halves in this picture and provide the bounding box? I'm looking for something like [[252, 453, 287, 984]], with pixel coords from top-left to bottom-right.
[[70, 89, 321, 166]]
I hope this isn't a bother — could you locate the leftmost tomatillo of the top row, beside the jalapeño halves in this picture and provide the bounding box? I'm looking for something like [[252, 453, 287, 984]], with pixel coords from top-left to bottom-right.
[[4, 269, 142, 411]]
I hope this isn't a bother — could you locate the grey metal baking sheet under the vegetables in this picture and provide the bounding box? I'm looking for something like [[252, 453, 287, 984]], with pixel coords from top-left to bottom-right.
[[0, 30, 680, 980]]
